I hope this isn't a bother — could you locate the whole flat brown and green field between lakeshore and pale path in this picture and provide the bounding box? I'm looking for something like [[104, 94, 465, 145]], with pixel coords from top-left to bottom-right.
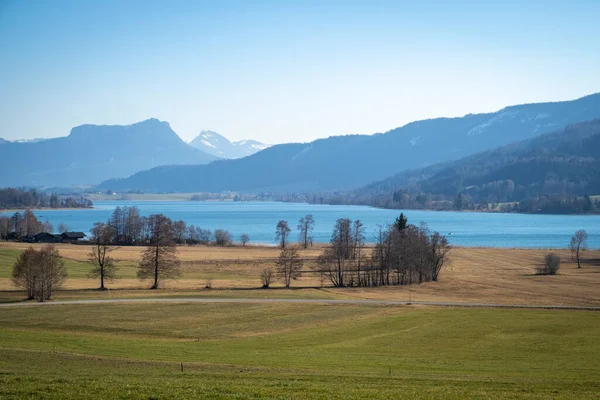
[[0, 243, 600, 306]]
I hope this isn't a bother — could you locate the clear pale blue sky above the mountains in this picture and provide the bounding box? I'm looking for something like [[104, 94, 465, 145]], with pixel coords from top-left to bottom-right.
[[0, 0, 600, 144]]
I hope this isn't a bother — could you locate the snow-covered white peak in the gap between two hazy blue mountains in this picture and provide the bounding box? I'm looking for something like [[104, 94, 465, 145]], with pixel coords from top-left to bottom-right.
[[190, 131, 269, 159]]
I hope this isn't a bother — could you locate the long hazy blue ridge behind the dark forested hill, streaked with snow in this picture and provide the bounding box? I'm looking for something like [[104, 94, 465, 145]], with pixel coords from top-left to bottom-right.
[[100, 93, 600, 192]]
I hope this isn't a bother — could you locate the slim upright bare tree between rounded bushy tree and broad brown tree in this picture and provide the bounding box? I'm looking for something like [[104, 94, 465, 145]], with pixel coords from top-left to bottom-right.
[[88, 222, 117, 290]]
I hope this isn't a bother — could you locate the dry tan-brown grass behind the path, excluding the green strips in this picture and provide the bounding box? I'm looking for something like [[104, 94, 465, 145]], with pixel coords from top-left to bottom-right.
[[0, 243, 600, 305]]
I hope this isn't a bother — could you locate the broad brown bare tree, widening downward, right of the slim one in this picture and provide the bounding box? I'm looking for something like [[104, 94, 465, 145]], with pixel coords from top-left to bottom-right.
[[137, 214, 181, 289]]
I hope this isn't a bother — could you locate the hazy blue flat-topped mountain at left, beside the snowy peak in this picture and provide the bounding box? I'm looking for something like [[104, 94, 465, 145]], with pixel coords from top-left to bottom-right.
[[0, 119, 218, 187]]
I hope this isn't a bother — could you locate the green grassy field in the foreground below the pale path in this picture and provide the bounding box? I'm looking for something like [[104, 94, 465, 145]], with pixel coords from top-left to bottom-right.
[[0, 303, 600, 399]]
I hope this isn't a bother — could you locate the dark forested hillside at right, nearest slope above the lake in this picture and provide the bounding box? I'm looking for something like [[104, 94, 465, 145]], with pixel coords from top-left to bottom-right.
[[354, 119, 600, 203]]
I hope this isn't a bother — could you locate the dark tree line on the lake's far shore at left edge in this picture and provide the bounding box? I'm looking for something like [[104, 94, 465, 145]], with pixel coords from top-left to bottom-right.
[[0, 188, 92, 209]]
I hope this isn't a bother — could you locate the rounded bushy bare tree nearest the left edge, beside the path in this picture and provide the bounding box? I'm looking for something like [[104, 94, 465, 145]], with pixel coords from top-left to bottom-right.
[[12, 244, 67, 302]]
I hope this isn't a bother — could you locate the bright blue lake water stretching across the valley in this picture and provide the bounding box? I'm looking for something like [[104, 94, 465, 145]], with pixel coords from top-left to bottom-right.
[[3, 201, 600, 248]]
